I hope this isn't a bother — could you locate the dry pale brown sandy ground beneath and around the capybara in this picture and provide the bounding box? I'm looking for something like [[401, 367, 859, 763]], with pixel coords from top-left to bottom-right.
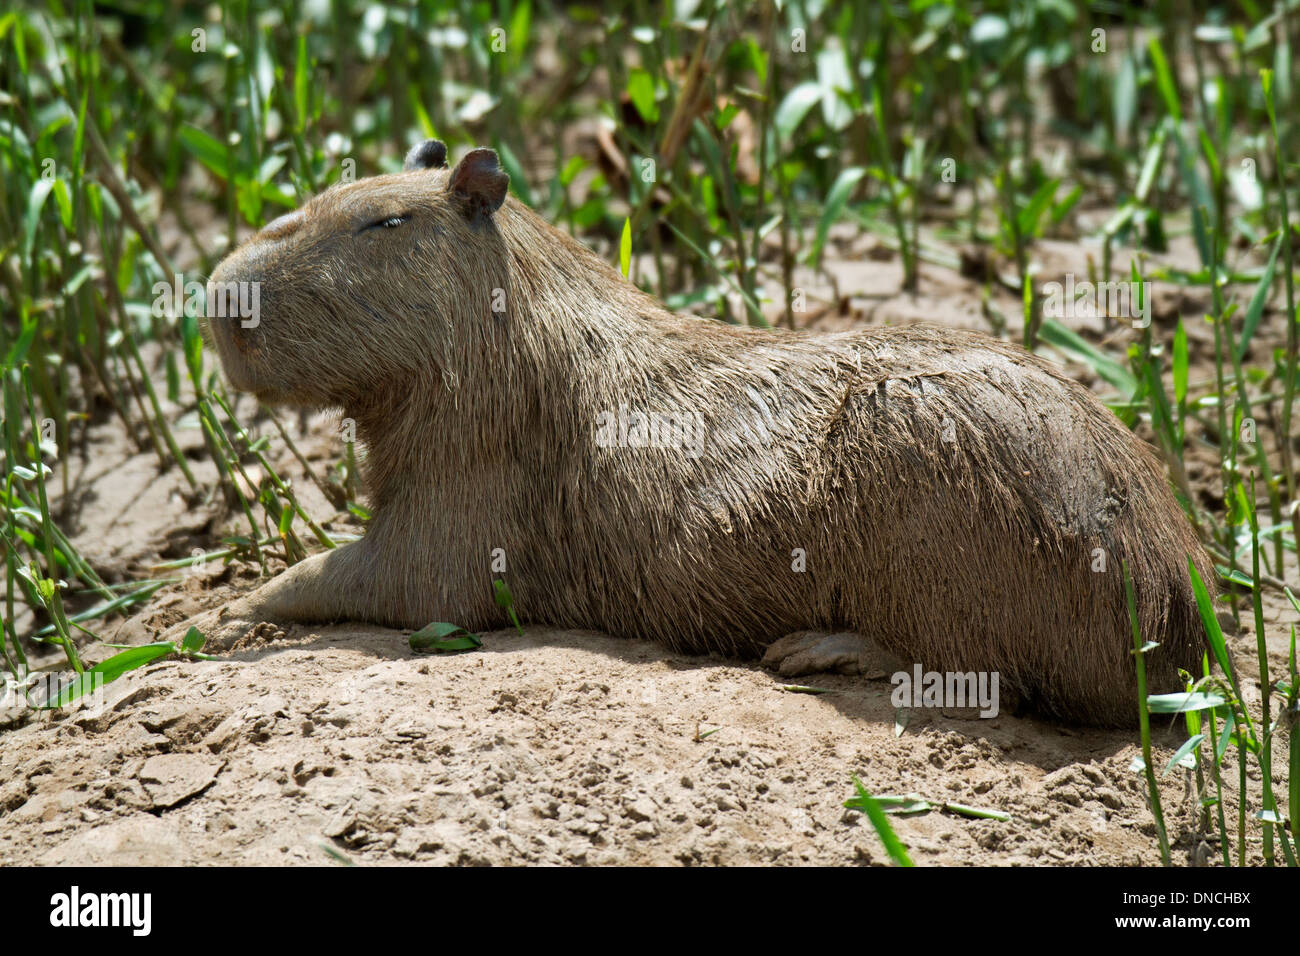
[[0, 226, 1296, 865]]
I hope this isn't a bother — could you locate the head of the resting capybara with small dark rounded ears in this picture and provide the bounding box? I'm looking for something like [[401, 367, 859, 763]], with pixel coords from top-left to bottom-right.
[[208, 139, 510, 406]]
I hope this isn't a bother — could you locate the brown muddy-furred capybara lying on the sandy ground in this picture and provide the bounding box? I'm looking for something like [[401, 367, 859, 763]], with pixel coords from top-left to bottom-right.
[[188, 140, 1214, 726]]
